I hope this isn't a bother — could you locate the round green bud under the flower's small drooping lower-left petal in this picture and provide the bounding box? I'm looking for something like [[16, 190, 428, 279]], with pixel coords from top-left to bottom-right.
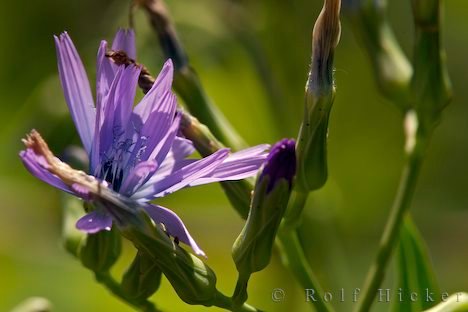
[[79, 207, 122, 273]]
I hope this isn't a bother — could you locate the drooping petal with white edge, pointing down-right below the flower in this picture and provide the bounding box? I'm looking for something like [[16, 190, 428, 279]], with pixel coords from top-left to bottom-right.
[[144, 204, 206, 257]]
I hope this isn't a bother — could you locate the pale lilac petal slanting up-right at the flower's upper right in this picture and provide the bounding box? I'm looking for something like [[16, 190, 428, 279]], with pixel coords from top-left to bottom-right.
[[134, 59, 174, 124]]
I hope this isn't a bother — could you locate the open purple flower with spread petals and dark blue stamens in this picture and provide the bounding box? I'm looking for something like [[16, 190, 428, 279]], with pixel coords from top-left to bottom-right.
[[20, 30, 269, 255]]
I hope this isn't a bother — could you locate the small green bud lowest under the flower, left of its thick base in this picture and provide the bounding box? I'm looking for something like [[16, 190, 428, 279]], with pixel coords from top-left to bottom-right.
[[121, 251, 162, 301]]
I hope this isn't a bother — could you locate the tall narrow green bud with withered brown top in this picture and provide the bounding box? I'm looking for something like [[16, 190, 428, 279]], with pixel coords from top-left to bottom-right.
[[297, 0, 341, 191]]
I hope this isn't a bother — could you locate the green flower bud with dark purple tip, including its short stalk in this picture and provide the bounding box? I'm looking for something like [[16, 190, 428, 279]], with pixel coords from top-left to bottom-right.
[[232, 139, 296, 304]]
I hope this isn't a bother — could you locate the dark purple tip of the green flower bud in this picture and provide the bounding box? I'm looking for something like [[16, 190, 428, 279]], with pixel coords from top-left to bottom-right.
[[260, 139, 296, 192]]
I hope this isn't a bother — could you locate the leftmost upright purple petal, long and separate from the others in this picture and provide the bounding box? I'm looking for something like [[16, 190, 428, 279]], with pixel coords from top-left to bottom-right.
[[54, 33, 95, 154]]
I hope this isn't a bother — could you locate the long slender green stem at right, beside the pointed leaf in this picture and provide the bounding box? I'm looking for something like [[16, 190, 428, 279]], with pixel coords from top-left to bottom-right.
[[356, 146, 424, 312]]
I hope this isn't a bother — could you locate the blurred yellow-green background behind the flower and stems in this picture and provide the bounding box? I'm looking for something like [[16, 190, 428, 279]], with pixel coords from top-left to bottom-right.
[[0, 0, 468, 312]]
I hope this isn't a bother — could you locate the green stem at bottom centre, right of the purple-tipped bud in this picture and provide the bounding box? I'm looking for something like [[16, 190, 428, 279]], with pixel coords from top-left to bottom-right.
[[278, 224, 333, 312]]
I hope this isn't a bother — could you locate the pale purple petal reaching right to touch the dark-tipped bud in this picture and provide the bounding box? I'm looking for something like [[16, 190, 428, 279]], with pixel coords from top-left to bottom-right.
[[190, 144, 270, 186]]
